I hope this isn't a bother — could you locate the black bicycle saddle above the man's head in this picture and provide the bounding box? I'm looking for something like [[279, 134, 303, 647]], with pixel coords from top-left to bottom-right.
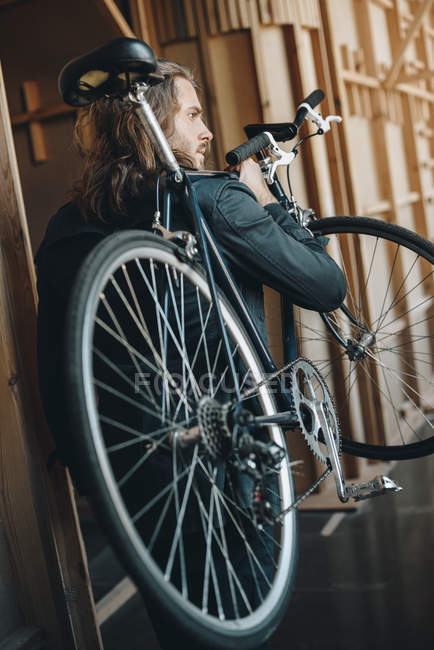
[[59, 38, 164, 106]]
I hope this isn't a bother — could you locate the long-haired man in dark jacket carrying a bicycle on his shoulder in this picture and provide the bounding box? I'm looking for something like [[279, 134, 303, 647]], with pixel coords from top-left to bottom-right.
[[36, 61, 345, 650]]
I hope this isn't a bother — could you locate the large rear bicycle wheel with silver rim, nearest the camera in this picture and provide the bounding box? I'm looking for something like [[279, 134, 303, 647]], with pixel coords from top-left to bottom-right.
[[66, 231, 296, 648]]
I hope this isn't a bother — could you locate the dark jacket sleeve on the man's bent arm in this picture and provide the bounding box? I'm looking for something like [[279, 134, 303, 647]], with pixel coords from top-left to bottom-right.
[[199, 181, 346, 312]]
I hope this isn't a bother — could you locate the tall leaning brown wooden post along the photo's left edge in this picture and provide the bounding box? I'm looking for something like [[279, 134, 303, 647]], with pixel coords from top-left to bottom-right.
[[0, 60, 99, 650]]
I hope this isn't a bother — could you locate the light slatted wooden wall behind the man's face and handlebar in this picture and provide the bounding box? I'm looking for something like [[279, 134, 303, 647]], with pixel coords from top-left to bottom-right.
[[129, 0, 434, 498]]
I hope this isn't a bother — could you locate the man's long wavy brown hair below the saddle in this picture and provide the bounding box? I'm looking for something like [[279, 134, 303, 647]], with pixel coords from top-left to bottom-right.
[[72, 59, 196, 220]]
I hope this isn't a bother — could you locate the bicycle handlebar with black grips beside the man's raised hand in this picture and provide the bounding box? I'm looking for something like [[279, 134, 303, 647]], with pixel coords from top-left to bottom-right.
[[226, 89, 325, 165]]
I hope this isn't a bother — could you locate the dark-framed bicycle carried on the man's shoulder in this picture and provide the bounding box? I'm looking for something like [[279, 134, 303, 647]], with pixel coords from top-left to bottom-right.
[[60, 39, 434, 648]]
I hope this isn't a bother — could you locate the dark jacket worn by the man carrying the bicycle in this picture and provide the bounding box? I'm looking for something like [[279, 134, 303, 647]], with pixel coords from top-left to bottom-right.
[[35, 176, 346, 491]]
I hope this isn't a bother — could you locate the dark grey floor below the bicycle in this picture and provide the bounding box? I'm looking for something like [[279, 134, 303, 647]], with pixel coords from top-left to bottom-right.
[[83, 456, 434, 650]]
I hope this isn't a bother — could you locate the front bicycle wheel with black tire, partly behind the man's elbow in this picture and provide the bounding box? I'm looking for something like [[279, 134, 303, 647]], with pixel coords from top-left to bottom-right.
[[298, 217, 434, 460]]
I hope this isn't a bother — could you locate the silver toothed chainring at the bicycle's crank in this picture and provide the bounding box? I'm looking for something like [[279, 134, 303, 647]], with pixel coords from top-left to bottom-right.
[[287, 357, 341, 464]]
